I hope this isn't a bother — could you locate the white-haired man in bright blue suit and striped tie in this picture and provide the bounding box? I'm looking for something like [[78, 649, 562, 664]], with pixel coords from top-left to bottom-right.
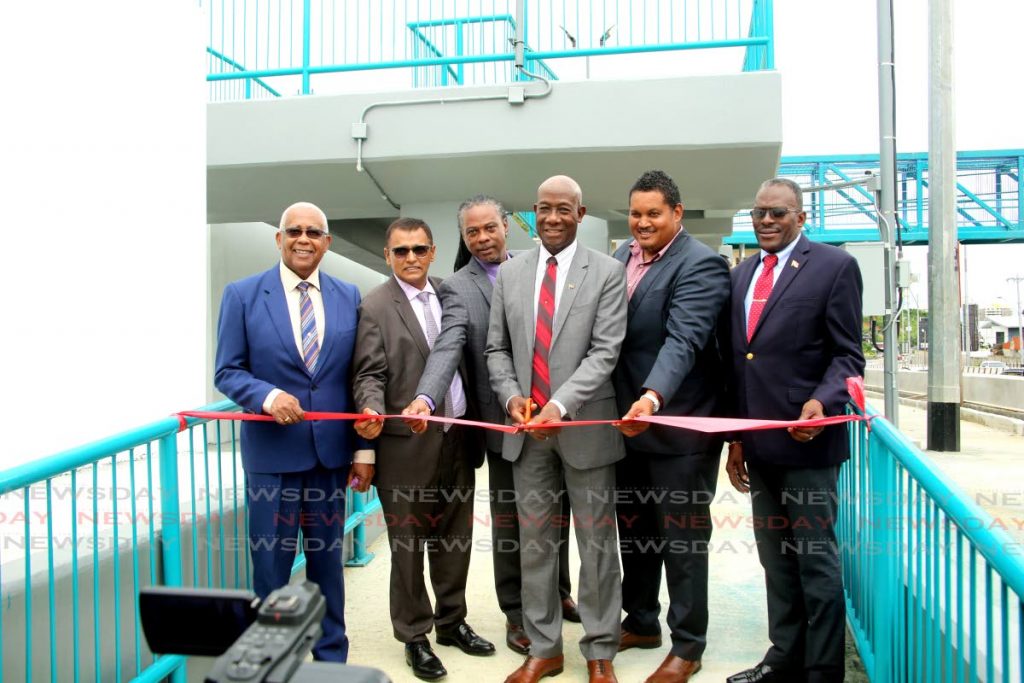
[[214, 203, 374, 661]]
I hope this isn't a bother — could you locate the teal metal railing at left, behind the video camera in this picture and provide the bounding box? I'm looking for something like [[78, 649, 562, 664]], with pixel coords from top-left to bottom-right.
[[0, 401, 380, 682]]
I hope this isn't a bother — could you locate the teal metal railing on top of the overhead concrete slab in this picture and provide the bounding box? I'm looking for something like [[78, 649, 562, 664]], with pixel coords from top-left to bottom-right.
[[203, 0, 774, 99]]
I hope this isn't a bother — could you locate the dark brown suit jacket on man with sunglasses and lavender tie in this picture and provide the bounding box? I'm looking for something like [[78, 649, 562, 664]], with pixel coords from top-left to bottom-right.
[[352, 276, 483, 488]]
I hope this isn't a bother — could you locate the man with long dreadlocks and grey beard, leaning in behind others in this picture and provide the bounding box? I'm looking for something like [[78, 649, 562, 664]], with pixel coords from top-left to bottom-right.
[[402, 195, 580, 654]]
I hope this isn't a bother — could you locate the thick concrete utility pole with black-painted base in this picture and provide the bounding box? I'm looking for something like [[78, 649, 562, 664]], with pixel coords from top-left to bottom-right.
[[928, 0, 961, 451]]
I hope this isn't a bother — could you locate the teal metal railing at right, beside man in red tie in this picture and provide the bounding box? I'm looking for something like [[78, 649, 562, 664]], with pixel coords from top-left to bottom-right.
[[837, 409, 1024, 683]]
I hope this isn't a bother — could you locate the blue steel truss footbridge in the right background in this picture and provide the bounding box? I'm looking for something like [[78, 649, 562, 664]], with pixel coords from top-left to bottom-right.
[[724, 150, 1024, 245]]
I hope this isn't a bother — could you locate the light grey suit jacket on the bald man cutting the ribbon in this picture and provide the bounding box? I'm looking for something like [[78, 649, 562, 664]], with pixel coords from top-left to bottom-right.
[[486, 245, 626, 469]]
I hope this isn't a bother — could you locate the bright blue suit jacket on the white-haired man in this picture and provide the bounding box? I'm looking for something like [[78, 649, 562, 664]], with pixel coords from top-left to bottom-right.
[[214, 265, 371, 473]]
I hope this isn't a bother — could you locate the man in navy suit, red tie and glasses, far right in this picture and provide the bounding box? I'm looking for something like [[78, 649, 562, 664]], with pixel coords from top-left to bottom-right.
[[726, 178, 864, 683]]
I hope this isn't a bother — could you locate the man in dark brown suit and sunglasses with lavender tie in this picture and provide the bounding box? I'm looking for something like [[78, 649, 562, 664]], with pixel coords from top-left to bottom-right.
[[353, 218, 495, 681]]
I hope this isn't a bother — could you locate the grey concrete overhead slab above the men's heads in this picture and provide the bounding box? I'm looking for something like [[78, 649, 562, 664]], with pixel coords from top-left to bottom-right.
[[207, 73, 781, 237]]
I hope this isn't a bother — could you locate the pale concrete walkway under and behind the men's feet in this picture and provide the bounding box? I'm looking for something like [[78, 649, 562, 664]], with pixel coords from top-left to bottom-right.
[[345, 401, 1024, 683]]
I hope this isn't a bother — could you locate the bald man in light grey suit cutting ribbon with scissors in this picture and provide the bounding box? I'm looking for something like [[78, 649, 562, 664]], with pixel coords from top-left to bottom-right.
[[486, 176, 626, 683]]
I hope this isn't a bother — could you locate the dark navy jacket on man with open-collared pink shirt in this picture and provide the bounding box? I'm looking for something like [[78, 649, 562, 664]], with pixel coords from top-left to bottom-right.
[[614, 231, 730, 455]]
